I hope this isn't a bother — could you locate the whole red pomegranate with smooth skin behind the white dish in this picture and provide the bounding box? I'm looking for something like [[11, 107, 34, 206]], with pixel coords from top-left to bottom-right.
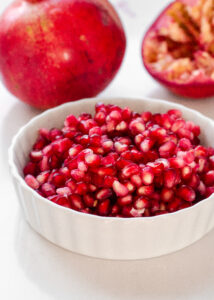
[[0, 0, 126, 109]]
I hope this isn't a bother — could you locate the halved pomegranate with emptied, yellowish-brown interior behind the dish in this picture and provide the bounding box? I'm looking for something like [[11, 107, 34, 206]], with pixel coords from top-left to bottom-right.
[[142, 0, 214, 98]]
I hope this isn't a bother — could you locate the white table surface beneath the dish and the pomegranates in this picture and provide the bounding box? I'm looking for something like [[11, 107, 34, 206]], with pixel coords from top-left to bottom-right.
[[0, 0, 214, 300]]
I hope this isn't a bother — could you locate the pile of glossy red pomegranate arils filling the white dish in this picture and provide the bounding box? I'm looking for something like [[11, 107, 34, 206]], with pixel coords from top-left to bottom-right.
[[23, 103, 214, 217]]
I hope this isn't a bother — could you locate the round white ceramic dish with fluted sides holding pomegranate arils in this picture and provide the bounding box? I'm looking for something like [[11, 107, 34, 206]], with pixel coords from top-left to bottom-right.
[[9, 98, 214, 259]]
